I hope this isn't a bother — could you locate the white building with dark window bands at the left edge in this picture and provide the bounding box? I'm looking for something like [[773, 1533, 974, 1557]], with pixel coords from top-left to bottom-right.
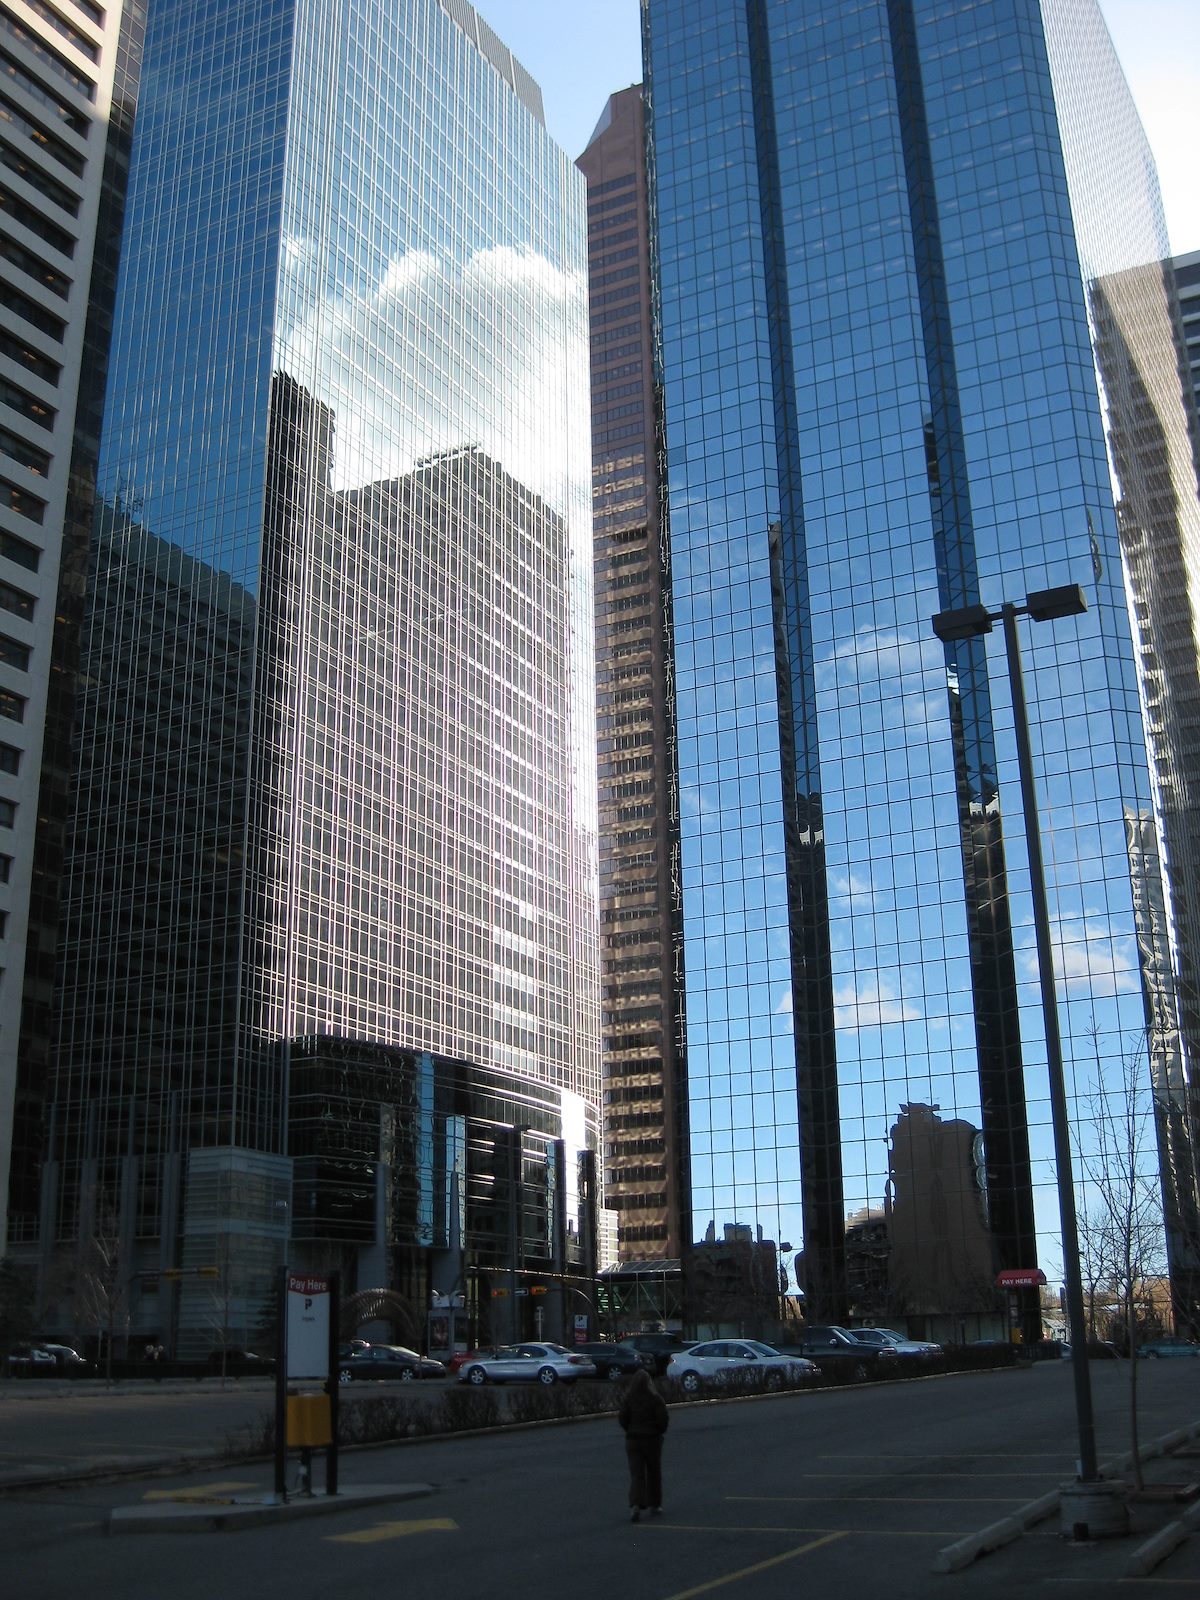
[[0, 5, 142, 1256]]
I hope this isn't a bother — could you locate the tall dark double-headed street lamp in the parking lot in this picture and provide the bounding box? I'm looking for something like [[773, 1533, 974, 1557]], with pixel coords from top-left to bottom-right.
[[933, 584, 1099, 1483]]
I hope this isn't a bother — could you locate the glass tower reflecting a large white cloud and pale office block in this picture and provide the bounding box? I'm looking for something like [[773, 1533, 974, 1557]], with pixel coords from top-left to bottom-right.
[[30, 0, 598, 1347]]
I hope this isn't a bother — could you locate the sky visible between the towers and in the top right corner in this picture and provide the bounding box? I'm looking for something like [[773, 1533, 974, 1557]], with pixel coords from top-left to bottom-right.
[[475, 0, 1200, 254]]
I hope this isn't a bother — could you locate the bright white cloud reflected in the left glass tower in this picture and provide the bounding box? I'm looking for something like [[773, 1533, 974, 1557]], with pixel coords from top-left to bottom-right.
[[278, 238, 587, 512]]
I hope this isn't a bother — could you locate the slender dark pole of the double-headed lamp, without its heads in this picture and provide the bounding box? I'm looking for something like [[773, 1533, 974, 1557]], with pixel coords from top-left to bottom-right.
[[1002, 602, 1099, 1483]]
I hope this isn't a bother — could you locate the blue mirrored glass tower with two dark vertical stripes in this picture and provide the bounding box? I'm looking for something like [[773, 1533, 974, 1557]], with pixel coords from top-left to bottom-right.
[[643, 0, 1195, 1338]]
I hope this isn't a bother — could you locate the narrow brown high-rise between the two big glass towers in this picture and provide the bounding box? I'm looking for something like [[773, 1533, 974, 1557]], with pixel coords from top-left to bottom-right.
[[578, 86, 686, 1261]]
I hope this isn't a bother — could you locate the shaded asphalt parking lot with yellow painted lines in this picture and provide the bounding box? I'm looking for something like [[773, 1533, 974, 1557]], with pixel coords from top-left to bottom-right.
[[0, 1363, 1200, 1600]]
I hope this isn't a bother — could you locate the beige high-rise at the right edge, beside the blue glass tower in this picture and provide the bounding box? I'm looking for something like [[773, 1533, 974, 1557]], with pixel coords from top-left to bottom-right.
[[1080, 240, 1200, 1309]]
